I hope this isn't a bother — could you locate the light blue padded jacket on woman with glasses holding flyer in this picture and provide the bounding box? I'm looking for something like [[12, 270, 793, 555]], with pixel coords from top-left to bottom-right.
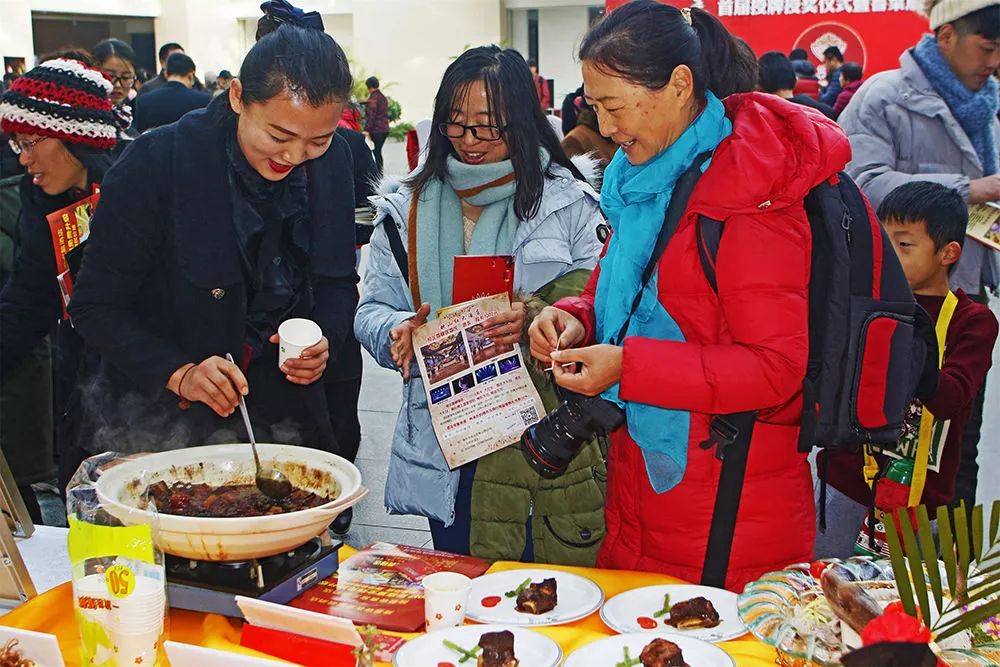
[[354, 164, 603, 526]]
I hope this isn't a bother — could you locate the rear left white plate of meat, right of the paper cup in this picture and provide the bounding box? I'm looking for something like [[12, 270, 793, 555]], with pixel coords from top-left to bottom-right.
[[467, 569, 604, 628]]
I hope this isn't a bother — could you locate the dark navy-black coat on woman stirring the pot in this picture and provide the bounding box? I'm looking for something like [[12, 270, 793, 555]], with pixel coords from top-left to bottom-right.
[[70, 97, 358, 451]]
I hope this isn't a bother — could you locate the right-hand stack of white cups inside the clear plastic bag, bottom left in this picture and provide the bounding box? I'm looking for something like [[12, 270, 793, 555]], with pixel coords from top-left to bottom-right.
[[106, 576, 167, 667]]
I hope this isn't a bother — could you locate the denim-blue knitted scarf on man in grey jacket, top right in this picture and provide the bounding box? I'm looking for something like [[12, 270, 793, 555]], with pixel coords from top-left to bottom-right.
[[910, 35, 1000, 176]]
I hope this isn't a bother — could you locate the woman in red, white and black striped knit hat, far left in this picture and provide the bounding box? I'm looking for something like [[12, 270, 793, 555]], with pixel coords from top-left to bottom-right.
[[0, 52, 128, 490]]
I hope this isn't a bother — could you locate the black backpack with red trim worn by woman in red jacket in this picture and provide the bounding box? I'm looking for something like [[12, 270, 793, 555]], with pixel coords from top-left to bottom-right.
[[696, 173, 937, 587]]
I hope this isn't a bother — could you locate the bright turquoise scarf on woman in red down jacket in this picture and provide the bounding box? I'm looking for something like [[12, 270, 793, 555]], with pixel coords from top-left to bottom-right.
[[594, 93, 733, 493]]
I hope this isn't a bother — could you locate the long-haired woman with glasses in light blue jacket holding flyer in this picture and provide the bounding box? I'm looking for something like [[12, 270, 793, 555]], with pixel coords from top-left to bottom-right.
[[354, 46, 604, 563]]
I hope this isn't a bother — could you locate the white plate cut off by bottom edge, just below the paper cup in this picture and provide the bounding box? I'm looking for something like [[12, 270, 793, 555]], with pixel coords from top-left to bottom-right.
[[392, 625, 562, 667]]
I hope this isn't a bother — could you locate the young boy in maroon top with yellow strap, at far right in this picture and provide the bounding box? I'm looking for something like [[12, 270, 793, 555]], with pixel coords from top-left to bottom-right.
[[816, 181, 997, 558]]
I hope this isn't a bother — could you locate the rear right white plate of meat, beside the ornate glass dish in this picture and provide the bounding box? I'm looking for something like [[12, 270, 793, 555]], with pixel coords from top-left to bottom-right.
[[601, 584, 747, 642]]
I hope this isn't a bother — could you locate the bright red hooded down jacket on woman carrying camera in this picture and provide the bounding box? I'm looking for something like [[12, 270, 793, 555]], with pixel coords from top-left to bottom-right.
[[556, 93, 851, 591]]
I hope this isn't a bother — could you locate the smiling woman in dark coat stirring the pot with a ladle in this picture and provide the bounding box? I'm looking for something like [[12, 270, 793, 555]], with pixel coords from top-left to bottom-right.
[[69, 25, 357, 478]]
